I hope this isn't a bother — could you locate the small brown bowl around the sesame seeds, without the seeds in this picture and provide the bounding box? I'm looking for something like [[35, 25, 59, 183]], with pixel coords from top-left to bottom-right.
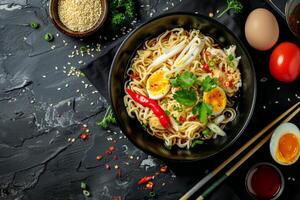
[[49, 0, 108, 38]]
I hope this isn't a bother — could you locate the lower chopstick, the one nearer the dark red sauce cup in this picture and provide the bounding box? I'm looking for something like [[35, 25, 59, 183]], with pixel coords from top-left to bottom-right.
[[197, 104, 300, 200]]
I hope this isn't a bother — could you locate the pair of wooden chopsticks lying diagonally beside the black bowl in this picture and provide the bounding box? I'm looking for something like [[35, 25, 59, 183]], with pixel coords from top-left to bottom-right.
[[180, 102, 300, 200]]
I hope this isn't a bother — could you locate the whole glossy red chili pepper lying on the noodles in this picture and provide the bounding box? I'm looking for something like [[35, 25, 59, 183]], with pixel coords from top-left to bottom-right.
[[126, 89, 170, 129]]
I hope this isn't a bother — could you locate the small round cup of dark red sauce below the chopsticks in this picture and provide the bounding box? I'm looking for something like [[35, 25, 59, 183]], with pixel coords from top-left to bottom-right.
[[246, 163, 283, 200]]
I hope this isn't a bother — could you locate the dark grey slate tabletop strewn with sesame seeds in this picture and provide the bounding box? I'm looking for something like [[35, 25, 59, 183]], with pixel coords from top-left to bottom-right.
[[0, 0, 300, 200]]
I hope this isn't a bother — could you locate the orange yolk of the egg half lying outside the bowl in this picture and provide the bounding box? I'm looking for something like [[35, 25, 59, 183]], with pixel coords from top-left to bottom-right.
[[277, 133, 299, 163]]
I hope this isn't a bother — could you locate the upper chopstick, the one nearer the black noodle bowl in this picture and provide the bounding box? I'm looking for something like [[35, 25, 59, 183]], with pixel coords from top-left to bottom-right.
[[180, 102, 300, 200]]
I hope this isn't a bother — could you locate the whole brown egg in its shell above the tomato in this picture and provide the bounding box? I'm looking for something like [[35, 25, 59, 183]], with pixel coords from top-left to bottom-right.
[[245, 8, 279, 51]]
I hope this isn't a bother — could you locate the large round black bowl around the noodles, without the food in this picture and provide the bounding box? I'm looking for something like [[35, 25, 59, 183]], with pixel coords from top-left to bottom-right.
[[109, 13, 256, 161]]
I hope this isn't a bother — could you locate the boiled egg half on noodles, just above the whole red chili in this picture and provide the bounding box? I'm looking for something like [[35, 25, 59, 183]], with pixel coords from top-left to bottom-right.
[[146, 68, 171, 100]]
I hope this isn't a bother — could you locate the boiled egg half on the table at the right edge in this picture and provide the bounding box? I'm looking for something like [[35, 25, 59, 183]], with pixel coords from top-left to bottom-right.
[[270, 123, 300, 165]]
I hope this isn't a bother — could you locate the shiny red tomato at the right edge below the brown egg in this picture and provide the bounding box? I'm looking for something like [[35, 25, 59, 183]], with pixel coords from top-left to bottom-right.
[[269, 42, 300, 83]]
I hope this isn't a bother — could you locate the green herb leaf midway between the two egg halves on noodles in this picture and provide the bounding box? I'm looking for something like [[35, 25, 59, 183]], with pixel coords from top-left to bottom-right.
[[173, 89, 197, 106]]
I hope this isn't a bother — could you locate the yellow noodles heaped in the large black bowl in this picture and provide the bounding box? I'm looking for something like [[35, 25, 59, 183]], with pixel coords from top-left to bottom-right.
[[123, 28, 241, 148]]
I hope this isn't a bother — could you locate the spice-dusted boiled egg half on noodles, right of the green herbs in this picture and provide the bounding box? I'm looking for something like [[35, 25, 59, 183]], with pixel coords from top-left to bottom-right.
[[203, 87, 227, 115]]
